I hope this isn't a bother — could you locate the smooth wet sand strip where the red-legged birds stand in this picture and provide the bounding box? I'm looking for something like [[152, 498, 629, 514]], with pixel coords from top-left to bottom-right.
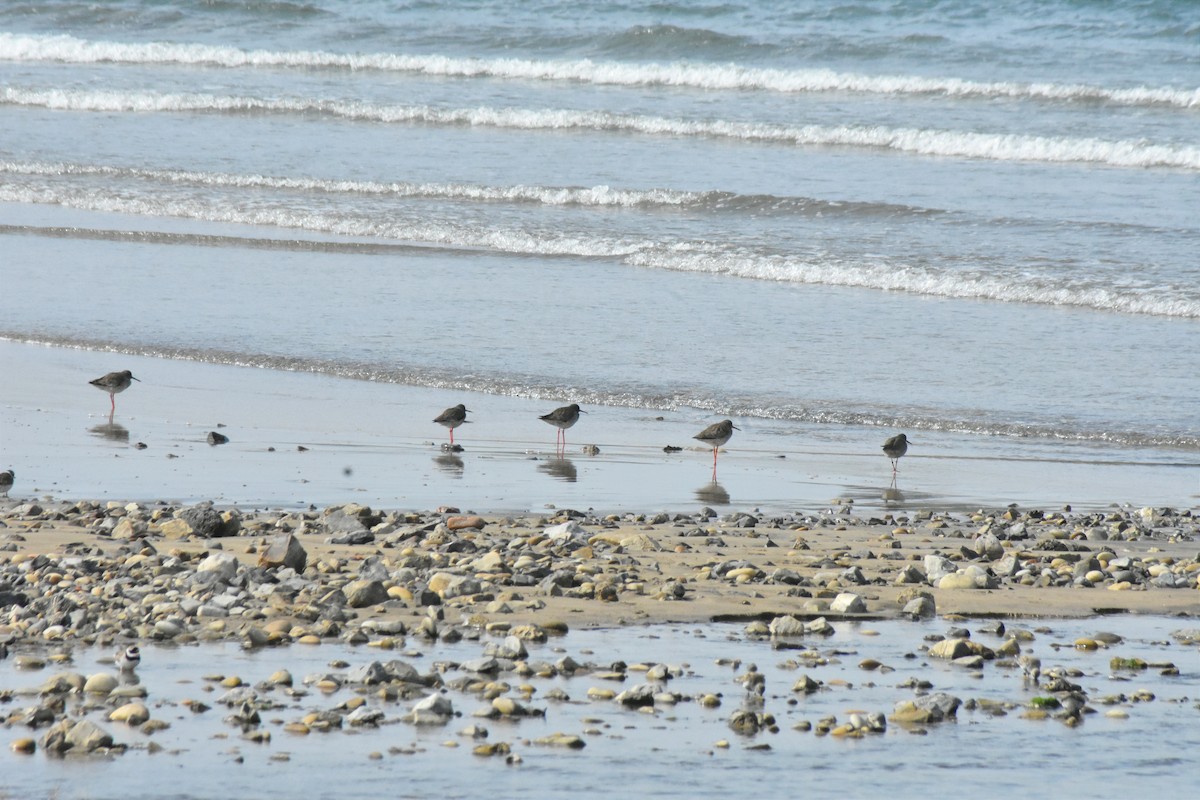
[[7, 339, 1200, 515]]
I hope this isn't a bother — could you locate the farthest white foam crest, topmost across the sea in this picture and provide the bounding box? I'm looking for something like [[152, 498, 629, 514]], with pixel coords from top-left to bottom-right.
[[0, 34, 1200, 108]]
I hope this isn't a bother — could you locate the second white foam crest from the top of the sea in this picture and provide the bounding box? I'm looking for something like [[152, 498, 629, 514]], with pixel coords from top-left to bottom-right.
[[0, 86, 1200, 170]]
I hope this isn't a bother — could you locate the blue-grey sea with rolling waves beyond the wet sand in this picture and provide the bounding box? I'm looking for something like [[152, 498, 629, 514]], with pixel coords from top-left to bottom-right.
[[0, 0, 1200, 505]]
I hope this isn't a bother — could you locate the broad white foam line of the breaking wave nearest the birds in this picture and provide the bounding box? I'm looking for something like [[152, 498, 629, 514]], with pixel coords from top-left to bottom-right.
[[0, 185, 1200, 319]]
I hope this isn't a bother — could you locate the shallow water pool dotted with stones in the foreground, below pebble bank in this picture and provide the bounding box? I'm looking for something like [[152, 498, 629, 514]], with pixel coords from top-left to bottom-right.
[[0, 616, 1200, 800]]
